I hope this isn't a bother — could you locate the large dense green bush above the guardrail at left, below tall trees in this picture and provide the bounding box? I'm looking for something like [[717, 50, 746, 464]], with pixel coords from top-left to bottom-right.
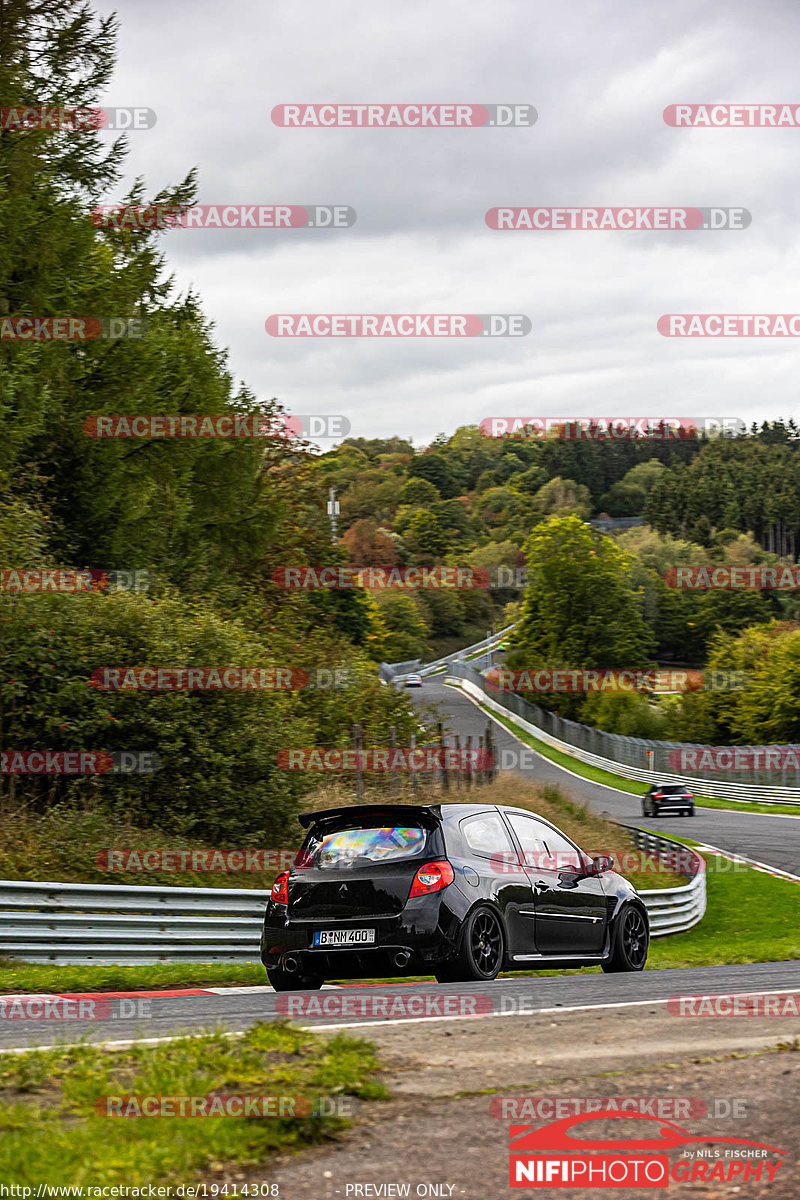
[[0, 594, 313, 845]]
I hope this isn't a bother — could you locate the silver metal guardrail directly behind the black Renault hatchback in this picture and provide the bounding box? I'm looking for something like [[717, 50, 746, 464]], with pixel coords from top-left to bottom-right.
[[0, 829, 705, 966]]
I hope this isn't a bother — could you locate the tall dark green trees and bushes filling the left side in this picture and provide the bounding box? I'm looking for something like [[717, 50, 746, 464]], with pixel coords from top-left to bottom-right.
[[0, 0, 415, 845]]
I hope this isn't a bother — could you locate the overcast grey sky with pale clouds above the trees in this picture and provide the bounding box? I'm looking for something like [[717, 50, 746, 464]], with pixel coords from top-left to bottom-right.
[[94, 0, 800, 444]]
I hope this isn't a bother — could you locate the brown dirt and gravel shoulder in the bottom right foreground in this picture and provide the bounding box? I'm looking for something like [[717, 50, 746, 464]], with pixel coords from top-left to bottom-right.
[[263, 1006, 800, 1200]]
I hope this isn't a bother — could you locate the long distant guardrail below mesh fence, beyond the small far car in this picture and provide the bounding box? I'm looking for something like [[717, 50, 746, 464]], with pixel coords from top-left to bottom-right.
[[449, 662, 800, 804]]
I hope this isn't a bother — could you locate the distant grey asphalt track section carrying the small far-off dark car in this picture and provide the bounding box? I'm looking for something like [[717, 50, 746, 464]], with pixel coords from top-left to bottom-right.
[[407, 678, 800, 875]]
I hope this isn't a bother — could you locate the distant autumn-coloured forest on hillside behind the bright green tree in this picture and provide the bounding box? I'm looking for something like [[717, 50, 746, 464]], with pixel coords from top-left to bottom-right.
[[317, 422, 800, 664]]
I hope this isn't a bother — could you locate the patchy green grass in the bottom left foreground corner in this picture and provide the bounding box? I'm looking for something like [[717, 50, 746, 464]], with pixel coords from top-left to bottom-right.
[[0, 1022, 386, 1187]]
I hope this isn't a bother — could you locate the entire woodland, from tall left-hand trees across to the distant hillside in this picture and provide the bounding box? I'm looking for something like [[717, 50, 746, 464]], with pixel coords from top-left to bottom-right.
[[0, 0, 800, 845]]
